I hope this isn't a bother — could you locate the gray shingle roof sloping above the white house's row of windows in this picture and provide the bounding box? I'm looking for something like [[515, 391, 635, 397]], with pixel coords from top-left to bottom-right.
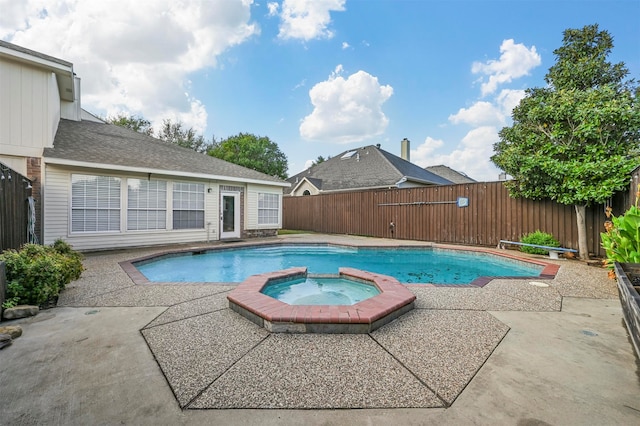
[[43, 119, 287, 186]]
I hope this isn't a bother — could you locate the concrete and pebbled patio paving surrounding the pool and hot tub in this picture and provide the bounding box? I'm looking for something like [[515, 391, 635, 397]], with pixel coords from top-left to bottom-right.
[[0, 235, 640, 425]]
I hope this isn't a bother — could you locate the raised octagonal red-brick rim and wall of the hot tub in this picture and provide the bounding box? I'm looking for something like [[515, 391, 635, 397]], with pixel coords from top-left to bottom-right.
[[227, 268, 416, 333]]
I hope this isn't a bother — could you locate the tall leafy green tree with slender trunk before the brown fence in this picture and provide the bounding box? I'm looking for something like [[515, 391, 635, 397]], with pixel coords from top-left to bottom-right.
[[491, 25, 640, 259]]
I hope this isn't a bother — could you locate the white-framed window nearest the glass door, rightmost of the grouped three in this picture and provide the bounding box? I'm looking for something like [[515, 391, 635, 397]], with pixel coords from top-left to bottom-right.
[[173, 182, 204, 229]]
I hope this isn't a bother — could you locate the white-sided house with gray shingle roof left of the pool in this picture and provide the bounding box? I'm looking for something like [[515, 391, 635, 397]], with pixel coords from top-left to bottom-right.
[[0, 41, 289, 250]]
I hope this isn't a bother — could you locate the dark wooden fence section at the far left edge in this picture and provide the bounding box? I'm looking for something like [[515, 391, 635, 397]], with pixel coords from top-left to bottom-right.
[[0, 163, 31, 252]]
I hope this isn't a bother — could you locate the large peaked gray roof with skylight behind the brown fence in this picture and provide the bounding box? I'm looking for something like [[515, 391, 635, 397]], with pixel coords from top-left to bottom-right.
[[285, 145, 451, 193]]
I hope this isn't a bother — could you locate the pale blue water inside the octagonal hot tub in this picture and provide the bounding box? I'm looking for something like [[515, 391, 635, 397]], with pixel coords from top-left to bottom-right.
[[261, 277, 380, 305]]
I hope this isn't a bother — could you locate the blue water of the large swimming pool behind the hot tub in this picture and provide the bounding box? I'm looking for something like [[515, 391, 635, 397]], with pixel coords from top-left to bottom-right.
[[135, 245, 542, 284]]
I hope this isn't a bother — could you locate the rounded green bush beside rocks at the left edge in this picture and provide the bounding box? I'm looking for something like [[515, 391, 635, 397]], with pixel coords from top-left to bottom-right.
[[0, 240, 84, 308]]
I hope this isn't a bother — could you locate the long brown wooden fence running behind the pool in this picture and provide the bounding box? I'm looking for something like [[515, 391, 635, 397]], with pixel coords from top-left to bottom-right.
[[283, 182, 623, 256]]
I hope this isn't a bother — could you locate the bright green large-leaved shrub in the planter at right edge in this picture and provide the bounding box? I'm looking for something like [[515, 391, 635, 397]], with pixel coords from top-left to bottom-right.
[[600, 196, 640, 270]]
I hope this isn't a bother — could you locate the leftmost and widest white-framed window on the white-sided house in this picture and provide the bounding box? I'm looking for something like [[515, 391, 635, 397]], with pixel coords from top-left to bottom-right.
[[71, 174, 120, 232]]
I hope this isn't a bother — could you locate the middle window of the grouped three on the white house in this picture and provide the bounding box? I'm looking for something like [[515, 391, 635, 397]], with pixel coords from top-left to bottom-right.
[[127, 179, 167, 231]]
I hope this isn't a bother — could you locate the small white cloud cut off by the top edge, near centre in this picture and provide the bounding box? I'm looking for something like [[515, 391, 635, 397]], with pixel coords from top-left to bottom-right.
[[276, 0, 346, 41]]
